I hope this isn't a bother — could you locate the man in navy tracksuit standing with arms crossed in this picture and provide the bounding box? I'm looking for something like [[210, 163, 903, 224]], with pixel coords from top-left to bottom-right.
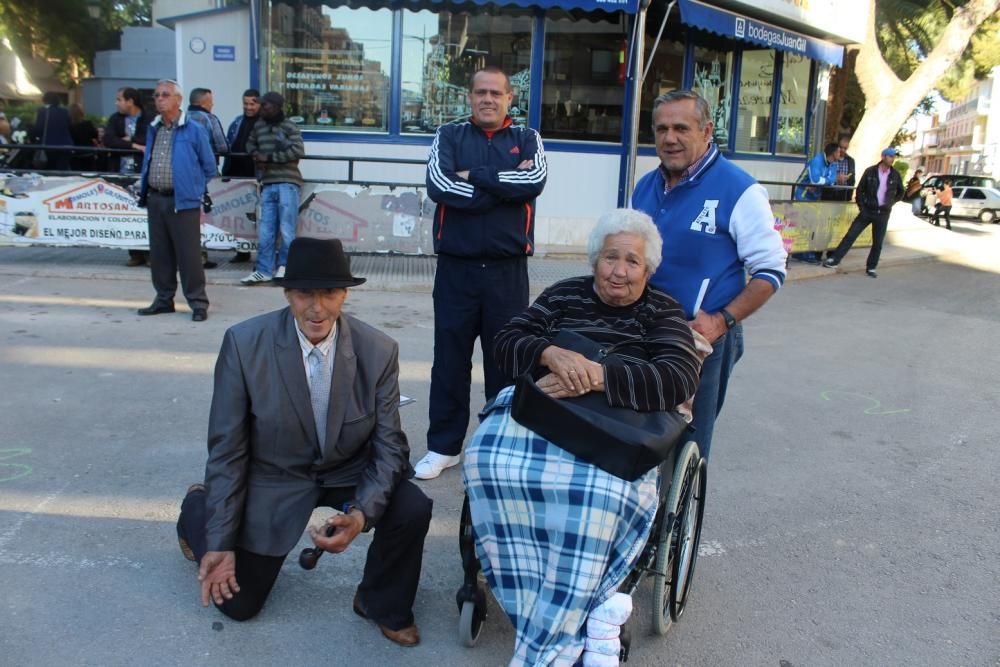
[[415, 67, 546, 479]]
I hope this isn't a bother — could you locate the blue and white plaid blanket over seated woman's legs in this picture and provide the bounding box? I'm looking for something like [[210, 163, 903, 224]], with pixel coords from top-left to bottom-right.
[[464, 387, 658, 665]]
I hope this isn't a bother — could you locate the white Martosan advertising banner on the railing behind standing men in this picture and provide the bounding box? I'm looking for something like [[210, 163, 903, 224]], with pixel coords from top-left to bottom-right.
[[0, 175, 434, 254]]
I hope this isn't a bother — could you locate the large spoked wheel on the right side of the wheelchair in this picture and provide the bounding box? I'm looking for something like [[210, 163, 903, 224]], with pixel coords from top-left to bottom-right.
[[653, 441, 705, 635]]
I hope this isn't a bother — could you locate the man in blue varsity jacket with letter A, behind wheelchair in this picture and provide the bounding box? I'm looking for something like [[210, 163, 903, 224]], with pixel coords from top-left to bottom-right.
[[632, 90, 785, 458]]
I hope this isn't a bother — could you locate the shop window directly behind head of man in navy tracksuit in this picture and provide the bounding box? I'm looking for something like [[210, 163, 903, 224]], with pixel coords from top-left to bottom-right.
[[401, 10, 532, 133]]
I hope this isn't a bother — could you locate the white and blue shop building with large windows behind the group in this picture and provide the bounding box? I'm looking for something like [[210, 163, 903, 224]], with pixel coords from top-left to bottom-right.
[[160, 0, 871, 251]]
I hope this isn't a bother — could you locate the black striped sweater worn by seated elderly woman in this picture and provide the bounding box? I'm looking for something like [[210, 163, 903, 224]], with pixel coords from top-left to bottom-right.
[[493, 276, 701, 411]]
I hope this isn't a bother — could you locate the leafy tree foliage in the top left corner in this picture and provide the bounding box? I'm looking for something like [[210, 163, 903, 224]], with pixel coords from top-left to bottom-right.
[[0, 0, 152, 85]]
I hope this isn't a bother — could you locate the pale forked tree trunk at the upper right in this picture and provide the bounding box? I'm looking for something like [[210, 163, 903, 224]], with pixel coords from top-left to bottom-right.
[[851, 0, 1000, 176]]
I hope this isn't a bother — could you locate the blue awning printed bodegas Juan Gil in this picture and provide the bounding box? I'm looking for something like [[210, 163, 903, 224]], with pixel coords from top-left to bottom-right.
[[680, 0, 844, 67]]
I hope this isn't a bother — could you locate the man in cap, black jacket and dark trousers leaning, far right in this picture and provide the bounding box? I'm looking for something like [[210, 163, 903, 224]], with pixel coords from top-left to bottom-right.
[[823, 148, 903, 278]]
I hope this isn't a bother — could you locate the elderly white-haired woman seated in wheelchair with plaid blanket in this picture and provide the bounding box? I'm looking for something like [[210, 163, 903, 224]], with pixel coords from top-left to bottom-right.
[[459, 209, 710, 665]]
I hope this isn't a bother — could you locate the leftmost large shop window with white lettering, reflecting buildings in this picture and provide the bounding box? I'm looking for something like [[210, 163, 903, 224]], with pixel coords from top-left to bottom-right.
[[265, 0, 392, 132]]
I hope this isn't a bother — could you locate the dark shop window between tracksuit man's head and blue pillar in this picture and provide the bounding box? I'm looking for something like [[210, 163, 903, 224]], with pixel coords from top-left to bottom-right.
[[540, 11, 628, 142]]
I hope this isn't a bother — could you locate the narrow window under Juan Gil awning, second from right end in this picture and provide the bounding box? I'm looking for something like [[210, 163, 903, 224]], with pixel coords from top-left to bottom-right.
[[736, 49, 774, 153]]
